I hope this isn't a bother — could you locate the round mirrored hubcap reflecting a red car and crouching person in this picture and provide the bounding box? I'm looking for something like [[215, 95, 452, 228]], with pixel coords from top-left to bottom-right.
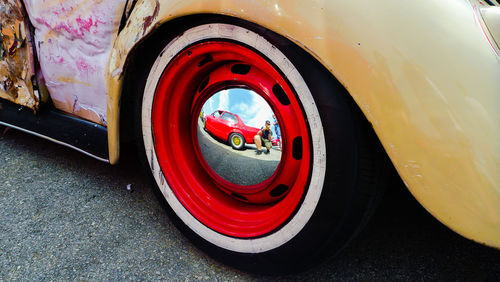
[[198, 88, 282, 186]]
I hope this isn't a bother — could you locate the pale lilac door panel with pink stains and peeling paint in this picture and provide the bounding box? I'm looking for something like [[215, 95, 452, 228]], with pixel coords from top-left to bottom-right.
[[24, 0, 126, 125]]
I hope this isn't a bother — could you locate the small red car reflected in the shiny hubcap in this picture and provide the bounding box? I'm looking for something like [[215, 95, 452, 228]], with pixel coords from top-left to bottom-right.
[[204, 110, 259, 149]]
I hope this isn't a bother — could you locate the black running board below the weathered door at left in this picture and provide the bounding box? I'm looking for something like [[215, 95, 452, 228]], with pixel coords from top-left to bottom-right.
[[0, 100, 109, 163]]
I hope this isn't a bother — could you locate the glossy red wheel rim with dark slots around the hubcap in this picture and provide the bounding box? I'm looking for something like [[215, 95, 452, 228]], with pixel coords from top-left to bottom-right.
[[152, 41, 311, 238]]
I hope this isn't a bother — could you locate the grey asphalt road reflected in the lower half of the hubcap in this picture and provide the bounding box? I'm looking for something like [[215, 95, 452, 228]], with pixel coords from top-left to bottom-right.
[[198, 121, 281, 185]]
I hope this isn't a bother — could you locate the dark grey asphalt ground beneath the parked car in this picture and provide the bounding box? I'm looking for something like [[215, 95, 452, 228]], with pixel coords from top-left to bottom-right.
[[0, 127, 500, 281]]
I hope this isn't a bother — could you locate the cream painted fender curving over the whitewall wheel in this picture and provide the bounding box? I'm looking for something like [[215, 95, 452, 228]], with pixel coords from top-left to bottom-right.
[[108, 0, 500, 248]]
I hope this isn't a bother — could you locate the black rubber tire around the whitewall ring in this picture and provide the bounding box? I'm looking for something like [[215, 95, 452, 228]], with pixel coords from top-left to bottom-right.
[[131, 16, 388, 274]]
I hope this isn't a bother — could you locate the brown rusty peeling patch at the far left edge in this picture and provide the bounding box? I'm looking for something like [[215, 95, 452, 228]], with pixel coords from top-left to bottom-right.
[[0, 0, 39, 110]]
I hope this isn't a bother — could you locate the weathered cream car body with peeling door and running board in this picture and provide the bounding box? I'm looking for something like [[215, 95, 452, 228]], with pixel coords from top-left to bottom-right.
[[0, 0, 500, 274]]
